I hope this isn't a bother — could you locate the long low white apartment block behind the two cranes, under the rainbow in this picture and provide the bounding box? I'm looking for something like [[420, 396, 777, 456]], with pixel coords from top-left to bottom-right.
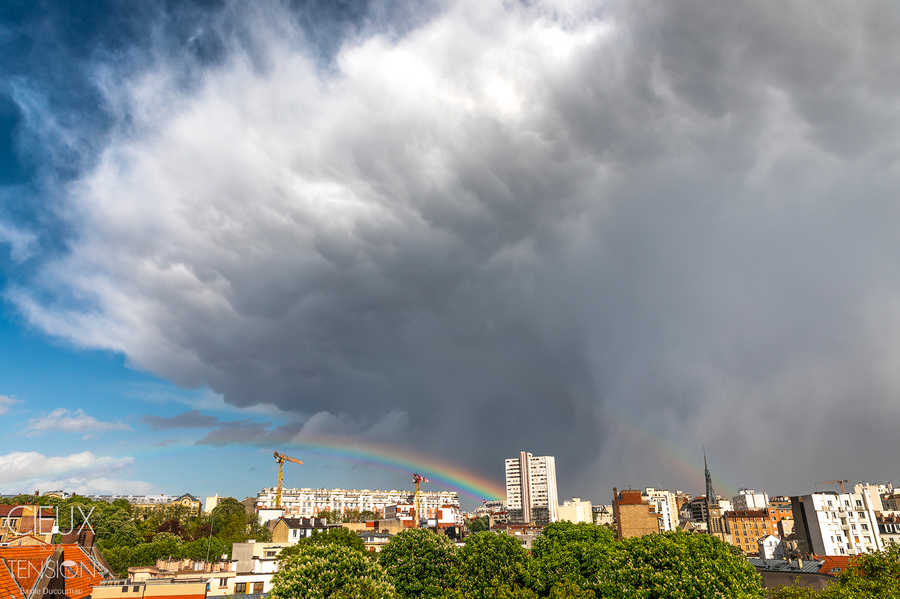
[[256, 487, 459, 518]]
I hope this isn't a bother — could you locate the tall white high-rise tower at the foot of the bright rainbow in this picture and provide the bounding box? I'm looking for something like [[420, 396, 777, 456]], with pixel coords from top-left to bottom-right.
[[505, 451, 559, 524]]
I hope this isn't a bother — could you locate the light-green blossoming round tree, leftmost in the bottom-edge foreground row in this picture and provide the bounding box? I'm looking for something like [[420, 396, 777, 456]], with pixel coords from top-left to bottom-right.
[[269, 543, 397, 599]]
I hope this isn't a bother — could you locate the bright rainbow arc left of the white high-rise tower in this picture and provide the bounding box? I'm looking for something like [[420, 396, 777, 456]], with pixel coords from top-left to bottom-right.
[[280, 435, 506, 501]]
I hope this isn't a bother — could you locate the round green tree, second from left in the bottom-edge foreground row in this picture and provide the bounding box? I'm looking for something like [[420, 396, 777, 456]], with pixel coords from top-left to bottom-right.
[[378, 528, 456, 598]]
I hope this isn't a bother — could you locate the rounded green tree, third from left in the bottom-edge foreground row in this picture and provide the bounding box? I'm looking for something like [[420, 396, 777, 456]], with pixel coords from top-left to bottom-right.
[[452, 531, 530, 599]]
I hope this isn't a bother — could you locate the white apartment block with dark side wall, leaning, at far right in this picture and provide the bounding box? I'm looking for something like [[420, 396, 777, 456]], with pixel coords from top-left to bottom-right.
[[791, 491, 883, 555]]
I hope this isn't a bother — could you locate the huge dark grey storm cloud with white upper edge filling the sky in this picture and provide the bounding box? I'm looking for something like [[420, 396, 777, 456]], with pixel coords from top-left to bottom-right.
[[7, 1, 900, 497]]
